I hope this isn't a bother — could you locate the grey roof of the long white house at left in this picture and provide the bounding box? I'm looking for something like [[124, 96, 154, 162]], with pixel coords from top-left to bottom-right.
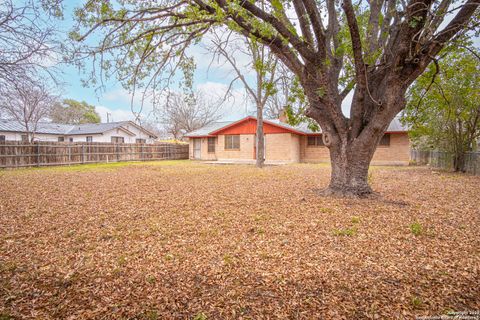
[[0, 120, 157, 137]]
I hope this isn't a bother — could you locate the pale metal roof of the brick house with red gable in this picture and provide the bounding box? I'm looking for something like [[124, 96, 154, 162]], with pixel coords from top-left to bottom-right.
[[185, 116, 408, 137]]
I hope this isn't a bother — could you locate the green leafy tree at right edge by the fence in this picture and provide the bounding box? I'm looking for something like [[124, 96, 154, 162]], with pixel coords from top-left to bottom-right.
[[403, 48, 480, 170]]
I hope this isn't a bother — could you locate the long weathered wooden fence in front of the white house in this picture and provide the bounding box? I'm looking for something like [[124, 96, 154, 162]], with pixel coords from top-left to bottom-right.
[[0, 141, 188, 168]]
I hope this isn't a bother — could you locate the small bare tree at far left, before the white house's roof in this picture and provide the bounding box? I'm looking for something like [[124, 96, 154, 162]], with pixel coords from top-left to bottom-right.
[[0, 82, 56, 142]]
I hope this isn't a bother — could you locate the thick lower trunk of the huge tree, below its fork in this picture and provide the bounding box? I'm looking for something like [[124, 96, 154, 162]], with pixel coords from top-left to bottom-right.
[[325, 138, 376, 197]]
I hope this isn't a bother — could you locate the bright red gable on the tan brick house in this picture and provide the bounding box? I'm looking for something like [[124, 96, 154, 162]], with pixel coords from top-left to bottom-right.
[[210, 116, 305, 135]]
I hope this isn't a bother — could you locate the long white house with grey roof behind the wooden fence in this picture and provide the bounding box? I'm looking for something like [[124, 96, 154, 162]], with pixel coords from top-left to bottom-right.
[[0, 120, 157, 143]]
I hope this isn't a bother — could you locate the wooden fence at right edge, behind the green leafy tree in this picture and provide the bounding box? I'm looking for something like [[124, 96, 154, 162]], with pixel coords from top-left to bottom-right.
[[411, 150, 480, 175]]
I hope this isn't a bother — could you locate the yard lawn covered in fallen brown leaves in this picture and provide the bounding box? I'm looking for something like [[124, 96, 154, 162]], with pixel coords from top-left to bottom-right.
[[0, 161, 480, 320]]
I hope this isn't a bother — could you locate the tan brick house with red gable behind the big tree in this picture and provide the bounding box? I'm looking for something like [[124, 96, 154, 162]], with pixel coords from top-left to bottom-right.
[[186, 116, 410, 165]]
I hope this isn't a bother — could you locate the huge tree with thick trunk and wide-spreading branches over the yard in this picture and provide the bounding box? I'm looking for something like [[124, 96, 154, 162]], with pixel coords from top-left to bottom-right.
[[72, 0, 480, 195]]
